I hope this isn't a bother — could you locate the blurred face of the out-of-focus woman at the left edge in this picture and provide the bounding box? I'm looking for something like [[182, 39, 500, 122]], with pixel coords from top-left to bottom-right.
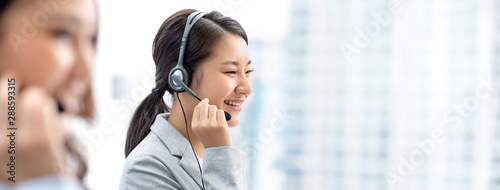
[[0, 0, 98, 114]]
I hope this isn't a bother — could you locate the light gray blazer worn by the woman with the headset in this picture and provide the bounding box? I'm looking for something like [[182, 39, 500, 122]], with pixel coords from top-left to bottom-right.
[[120, 113, 246, 190]]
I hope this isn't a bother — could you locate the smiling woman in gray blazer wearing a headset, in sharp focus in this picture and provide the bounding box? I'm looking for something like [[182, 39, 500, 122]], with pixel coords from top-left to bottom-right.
[[120, 10, 253, 189]]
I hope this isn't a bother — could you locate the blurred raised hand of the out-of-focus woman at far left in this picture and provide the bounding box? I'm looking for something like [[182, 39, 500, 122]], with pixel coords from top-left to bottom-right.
[[0, 73, 67, 185]]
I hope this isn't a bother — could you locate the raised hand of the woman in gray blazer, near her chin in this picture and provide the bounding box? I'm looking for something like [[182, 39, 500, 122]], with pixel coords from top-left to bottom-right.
[[191, 98, 231, 148]]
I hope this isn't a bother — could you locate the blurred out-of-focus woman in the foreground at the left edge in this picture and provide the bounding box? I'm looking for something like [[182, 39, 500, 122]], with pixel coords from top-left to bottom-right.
[[0, 0, 98, 190]]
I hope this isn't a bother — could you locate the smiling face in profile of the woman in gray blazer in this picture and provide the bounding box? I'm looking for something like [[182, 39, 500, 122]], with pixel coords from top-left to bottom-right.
[[191, 33, 252, 127]]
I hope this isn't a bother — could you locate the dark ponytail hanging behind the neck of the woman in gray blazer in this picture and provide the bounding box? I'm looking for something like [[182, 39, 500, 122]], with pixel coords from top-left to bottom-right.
[[125, 88, 170, 158]]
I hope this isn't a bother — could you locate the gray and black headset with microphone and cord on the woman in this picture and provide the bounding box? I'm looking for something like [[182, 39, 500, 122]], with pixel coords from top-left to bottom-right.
[[168, 11, 231, 189]]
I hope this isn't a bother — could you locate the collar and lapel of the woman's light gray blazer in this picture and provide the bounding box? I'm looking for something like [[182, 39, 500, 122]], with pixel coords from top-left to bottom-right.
[[151, 113, 202, 188]]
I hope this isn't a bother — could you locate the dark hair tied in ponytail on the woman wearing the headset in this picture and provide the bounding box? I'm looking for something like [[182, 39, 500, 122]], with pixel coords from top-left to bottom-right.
[[125, 9, 248, 157]]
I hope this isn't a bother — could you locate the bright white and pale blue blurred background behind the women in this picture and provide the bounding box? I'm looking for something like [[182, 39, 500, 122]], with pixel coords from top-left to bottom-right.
[[74, 0, 500, 190]]
